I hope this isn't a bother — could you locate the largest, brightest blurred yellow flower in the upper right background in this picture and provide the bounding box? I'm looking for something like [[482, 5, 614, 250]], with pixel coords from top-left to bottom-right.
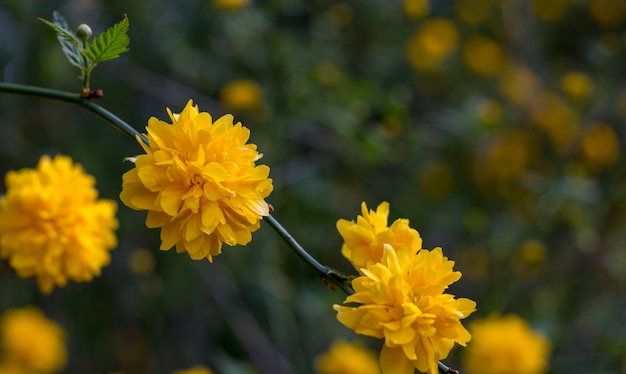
[[406, 18, 459, 71]]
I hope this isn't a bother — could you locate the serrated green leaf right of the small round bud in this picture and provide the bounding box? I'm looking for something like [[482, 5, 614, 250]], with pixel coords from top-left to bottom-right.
[[84, 16, 130, 65]]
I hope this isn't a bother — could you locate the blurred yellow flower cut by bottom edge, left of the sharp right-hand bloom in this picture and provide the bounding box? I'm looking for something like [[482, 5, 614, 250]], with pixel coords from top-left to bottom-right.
[[315, 341, 380, 374]]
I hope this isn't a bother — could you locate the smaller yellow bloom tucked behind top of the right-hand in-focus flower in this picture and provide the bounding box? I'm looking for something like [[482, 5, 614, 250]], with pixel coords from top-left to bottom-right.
[[337, 202, 422, 271]]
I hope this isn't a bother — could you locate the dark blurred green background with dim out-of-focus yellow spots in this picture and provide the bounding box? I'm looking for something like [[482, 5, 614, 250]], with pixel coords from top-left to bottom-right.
[[0, 0, 626, 374]]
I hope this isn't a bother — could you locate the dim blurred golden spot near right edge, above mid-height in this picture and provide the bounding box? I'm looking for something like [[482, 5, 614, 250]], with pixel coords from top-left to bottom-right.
[[582, 123, 620, 168]]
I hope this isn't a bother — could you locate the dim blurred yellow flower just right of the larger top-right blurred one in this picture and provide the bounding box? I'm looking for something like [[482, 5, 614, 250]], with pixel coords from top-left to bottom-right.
[[463, 35, 505, 76]]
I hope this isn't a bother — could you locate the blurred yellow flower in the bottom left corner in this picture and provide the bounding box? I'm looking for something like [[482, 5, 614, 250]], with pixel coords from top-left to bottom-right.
[[0, 307, 67, 374]]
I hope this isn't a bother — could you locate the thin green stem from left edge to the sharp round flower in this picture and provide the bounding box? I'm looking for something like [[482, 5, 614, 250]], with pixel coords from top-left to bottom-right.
[[0, 82, 148, 144]]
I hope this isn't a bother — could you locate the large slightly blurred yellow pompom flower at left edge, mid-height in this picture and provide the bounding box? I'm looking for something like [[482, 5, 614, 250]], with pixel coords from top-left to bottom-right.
[[0, 156, 118, 293]]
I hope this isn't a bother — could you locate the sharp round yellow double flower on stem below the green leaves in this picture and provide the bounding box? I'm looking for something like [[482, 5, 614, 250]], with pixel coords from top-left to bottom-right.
[[120, 100, 273, 261]]
